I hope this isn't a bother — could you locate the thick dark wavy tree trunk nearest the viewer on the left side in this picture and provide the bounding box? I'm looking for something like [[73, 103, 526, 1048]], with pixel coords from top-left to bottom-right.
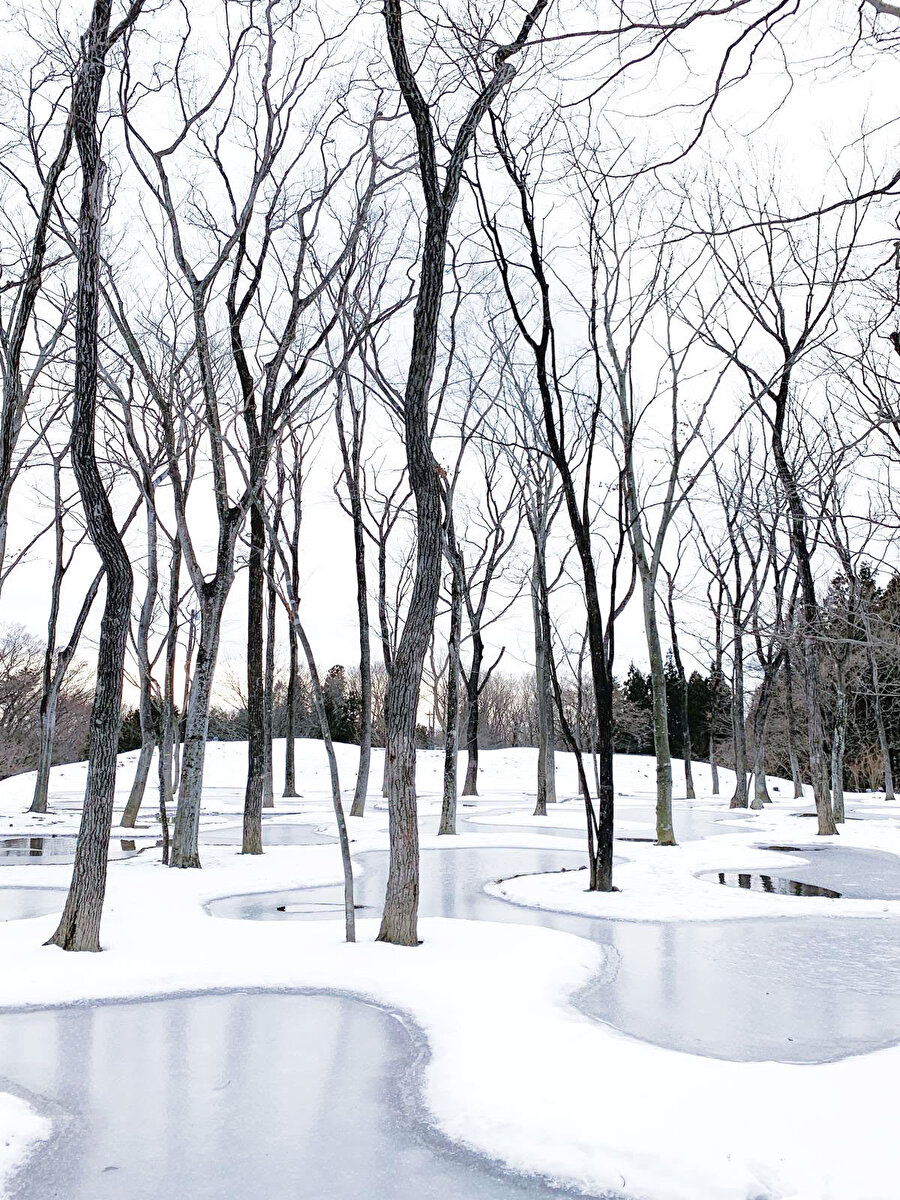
[[49, 0, 139, 950]]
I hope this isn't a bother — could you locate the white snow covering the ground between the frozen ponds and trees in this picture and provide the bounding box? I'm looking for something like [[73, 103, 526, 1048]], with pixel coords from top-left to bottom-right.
[[0, 743, 900, 1200]]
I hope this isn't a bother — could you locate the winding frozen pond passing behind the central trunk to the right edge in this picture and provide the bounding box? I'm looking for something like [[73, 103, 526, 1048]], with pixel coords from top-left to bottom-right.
[[208, 846, 900, 1062]]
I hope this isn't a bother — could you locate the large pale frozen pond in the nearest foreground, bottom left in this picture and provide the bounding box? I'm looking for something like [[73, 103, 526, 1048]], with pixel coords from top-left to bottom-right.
[[0, 992, 607, 1200]]
